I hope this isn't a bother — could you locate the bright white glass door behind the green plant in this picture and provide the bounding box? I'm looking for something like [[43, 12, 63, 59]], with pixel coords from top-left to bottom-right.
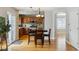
[[7, 12, 16, 45]]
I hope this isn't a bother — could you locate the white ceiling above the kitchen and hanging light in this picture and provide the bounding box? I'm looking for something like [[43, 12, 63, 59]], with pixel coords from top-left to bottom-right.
[[15, 7, 53, 15]]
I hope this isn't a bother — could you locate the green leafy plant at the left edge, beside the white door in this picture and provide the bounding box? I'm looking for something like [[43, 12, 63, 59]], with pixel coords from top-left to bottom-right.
[[0, 16, 10, 49]]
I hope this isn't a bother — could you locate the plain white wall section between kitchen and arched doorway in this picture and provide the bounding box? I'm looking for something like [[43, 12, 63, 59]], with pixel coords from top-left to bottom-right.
[[44, 11, 53, 39]]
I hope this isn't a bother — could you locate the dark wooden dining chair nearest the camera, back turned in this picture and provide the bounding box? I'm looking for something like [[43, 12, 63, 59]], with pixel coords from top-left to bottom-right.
[[35, 30, 44, 47]]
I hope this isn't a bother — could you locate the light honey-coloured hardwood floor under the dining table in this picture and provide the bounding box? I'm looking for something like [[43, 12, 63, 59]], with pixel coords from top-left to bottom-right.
[[8, 36, 76, 51]]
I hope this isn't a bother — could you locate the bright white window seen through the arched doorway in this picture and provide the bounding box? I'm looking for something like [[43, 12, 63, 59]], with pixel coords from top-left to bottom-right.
[[56, 13, 66, 29]]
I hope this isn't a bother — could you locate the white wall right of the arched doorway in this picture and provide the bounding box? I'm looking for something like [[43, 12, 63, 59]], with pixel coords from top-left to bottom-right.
[[68, 8, 79, 49]]
